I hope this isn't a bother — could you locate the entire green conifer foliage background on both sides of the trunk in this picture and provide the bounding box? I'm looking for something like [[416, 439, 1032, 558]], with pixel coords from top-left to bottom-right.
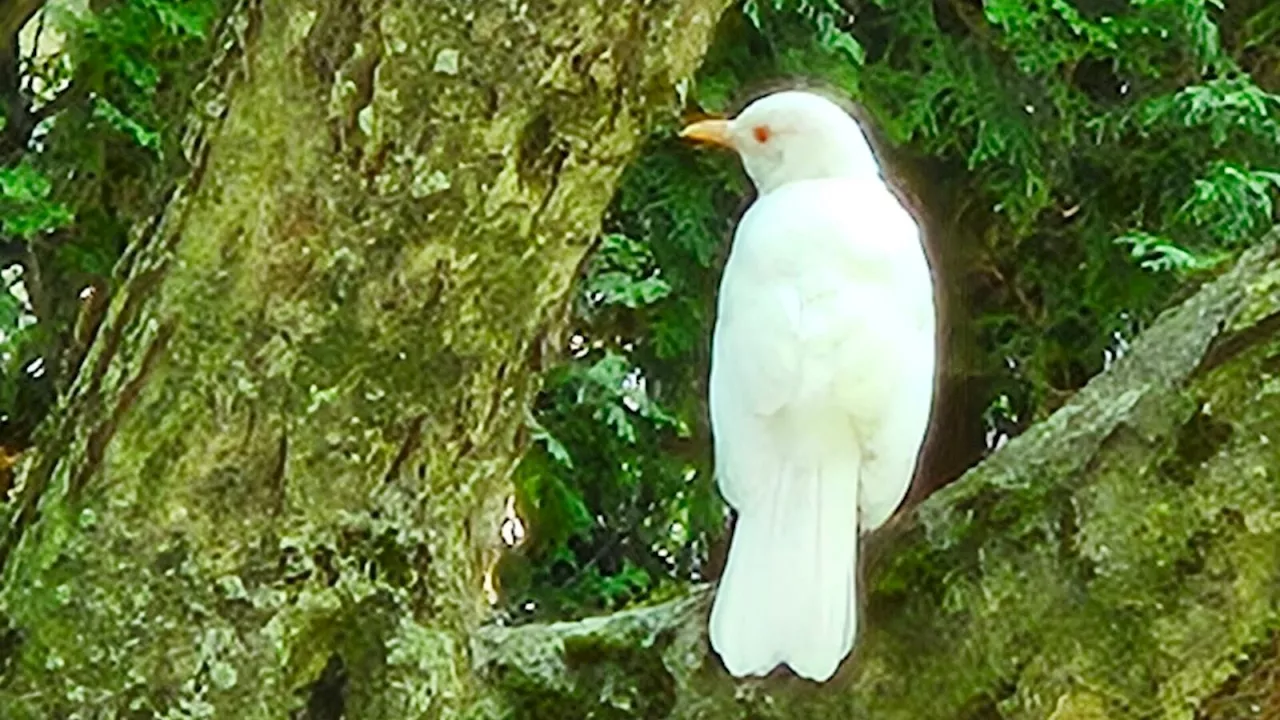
[[0, 0, 1280, 621]]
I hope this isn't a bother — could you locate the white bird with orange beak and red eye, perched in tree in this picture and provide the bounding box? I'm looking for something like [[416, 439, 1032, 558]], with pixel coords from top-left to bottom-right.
[[681, 91, 936, 682]]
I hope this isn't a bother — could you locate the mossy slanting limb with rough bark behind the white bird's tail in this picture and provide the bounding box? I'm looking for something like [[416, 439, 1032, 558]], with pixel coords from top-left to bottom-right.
[[474, 232, 1280, 720]]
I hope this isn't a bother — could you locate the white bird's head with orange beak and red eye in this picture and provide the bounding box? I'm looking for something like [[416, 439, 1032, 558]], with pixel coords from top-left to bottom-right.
[[680, 90, 879, 195]]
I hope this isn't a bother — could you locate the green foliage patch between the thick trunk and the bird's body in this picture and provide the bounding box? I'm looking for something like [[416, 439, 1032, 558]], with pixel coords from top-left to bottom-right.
[[500, 146, 741, 618]]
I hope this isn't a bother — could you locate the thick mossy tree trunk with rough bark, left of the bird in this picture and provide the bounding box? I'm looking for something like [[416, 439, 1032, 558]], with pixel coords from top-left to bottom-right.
[[0, 0, 727, 720]]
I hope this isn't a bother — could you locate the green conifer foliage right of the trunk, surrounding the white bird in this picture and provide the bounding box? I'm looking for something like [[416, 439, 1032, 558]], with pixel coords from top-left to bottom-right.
[[507, 0, 1280, 614]]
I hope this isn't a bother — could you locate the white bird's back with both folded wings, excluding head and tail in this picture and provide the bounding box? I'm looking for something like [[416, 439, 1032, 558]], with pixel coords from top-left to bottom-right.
[[709, 181, 934, 511]]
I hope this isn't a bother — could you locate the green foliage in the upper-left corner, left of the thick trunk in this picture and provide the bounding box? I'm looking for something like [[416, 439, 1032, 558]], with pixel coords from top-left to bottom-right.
[[0, 0, 221, 445]]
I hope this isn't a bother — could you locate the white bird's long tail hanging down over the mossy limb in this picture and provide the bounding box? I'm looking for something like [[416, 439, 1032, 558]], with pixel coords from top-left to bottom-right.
[[710, 442, 860, 682]]
